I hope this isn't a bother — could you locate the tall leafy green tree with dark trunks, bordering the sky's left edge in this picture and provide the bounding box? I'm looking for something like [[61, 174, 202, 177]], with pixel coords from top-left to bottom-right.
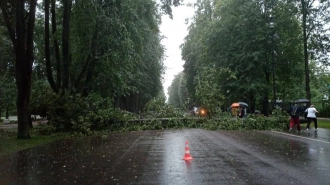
[[39, 0, 169, 111]]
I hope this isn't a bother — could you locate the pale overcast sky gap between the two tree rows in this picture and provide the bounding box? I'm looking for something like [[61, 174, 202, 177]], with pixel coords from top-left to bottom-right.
[[160, 0, 196, 99]]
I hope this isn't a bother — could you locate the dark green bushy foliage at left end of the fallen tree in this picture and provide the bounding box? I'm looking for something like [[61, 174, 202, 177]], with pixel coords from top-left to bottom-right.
[[46, 91, 138, 135]]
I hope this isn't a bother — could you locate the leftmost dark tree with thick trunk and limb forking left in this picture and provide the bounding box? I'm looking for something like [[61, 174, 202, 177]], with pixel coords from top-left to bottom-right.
[[0, 0, 37, 139]]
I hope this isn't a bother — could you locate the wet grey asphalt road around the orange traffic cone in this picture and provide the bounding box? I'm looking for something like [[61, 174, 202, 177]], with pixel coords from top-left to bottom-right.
[[0, 129, 330, 185]]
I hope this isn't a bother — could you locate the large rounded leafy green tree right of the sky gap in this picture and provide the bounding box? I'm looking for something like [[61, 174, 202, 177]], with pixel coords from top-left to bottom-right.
[[182, 0, 301, 116]]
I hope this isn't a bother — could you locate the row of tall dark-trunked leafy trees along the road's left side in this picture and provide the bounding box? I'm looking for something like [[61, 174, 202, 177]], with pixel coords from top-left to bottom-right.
[[0, 0, 181, 139]]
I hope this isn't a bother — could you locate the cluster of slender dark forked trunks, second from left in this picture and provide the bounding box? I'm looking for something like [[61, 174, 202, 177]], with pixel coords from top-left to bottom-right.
[[44, 0, 72, 92]]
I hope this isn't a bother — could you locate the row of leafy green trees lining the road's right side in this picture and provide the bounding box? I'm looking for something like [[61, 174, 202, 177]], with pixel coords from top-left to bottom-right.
[[169, 0, 330, 116]]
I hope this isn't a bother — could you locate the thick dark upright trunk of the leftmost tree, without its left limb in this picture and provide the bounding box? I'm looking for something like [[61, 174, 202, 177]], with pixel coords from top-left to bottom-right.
[[15, 0, 37, 139]]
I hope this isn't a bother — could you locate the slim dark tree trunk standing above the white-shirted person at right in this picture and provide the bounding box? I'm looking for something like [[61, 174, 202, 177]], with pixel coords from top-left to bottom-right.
[[301, 0, 311, 100]]
